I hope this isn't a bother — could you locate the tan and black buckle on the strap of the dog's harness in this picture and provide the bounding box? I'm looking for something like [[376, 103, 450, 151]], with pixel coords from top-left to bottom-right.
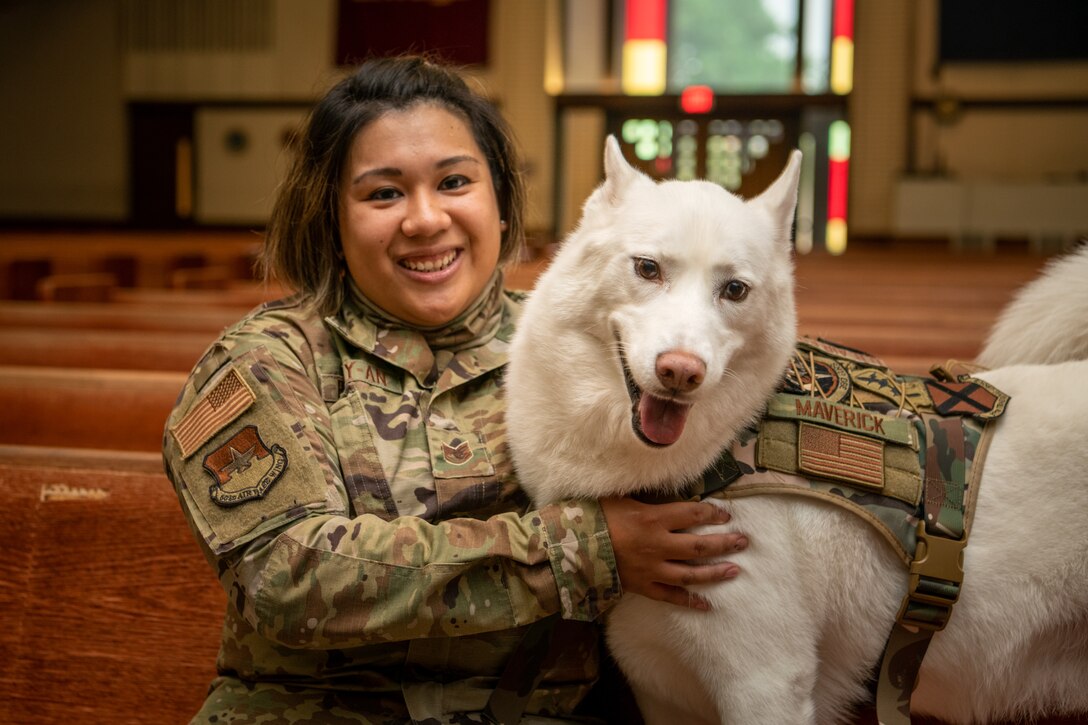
[[895, 521, 967, 631]]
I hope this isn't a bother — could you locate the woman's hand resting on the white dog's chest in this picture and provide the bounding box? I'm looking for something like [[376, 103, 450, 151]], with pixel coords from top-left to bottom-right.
[[601, 497, 747, 610]]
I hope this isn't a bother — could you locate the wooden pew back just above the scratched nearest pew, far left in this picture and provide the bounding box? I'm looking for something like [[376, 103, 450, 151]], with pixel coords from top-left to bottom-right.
[[0, 366, 187, 453]]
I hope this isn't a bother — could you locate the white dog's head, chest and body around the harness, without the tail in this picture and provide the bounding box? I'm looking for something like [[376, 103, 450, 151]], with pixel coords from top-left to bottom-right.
[[507, 139, 1088, 725]]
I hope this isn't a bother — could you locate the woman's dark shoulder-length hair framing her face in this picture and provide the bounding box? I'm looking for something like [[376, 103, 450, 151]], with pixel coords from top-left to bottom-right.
[[260, 57, 526, 315]]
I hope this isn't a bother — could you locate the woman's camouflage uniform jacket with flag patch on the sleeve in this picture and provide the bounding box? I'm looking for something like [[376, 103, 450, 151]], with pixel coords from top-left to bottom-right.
[[164, 275, 620, 723]]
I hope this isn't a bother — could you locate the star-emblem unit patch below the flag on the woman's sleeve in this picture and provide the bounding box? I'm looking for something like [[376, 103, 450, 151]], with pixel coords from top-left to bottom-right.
[[203, 426, 287, 506]]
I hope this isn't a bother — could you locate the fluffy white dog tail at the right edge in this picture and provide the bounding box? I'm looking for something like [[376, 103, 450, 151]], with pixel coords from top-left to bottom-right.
[[978, 242, 1088, 368]]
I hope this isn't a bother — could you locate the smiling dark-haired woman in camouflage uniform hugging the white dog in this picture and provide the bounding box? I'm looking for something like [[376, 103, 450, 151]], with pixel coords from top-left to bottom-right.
[[164, 53, 744, 723]]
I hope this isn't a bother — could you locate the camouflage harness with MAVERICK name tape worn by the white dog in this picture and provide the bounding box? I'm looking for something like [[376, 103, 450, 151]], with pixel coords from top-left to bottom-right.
[[702, 339, 1009, 724]]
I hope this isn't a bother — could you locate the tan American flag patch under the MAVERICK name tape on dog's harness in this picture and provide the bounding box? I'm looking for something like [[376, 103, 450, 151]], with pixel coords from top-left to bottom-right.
[[798, 422, 883, 489]]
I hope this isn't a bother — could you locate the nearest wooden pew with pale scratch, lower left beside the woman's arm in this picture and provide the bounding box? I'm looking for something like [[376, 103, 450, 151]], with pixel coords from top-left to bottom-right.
[[0, 445, 226, 725]]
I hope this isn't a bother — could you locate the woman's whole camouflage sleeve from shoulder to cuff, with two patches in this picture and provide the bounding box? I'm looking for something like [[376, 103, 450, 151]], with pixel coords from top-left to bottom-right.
[[164, 315, 619, 649]]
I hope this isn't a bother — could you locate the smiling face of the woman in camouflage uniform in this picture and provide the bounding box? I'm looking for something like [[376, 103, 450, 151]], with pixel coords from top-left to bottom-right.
[[339, 103, 503, 328]]
